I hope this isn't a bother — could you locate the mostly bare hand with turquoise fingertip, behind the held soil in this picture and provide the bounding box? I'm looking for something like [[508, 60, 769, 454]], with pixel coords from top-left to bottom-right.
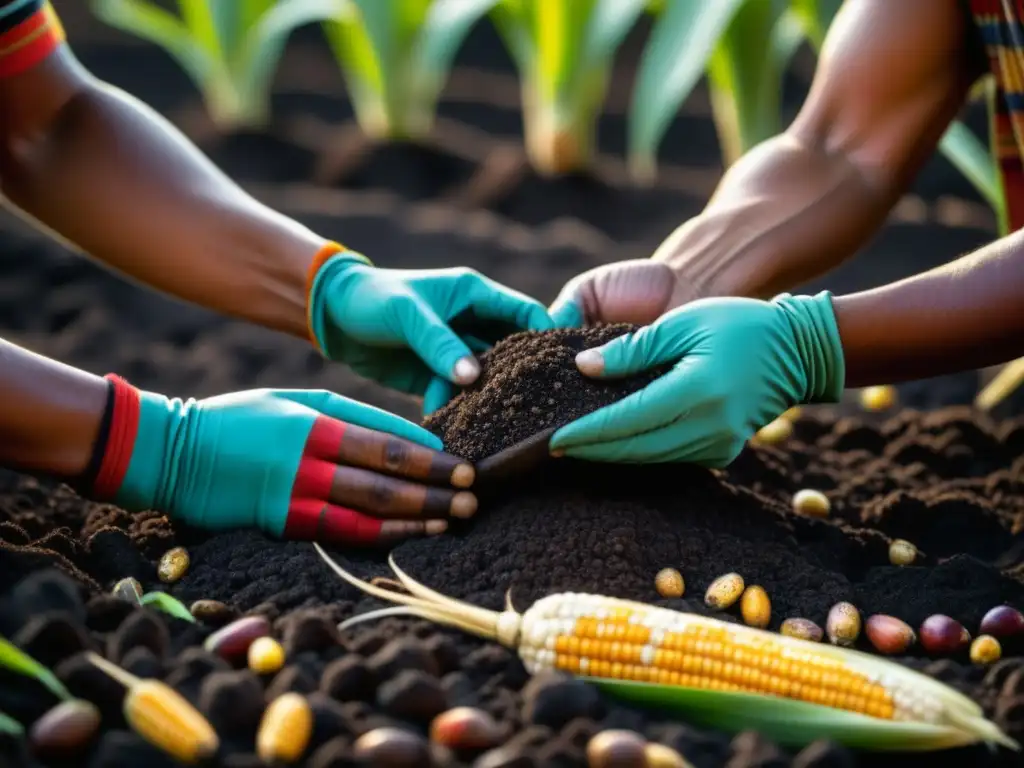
[[549, 259, 697, 328]]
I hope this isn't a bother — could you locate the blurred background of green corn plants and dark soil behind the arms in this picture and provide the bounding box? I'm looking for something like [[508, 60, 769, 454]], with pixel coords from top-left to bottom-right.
[[0, 0, 1005, 415]]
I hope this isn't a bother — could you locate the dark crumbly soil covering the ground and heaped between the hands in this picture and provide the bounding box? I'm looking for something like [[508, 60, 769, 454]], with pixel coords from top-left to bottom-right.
[[0, 0, 1024, 768]]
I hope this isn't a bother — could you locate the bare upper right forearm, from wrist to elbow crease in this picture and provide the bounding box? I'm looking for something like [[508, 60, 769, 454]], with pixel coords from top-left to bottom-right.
[[654, 134, 898, 304]]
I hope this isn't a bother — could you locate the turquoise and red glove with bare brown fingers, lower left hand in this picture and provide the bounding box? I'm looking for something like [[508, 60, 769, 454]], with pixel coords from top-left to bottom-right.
[[93, 376, 476, 544]]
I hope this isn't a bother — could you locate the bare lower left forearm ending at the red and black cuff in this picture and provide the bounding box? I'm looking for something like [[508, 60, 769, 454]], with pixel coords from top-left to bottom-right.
[[0, 339, 108, 478]]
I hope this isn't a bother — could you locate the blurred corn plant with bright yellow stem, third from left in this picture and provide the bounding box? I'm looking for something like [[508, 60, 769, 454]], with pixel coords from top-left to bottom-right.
[[490, 0, 647, 175]]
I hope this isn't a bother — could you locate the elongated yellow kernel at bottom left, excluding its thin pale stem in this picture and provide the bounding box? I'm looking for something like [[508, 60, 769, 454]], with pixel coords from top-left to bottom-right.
[[124, 680, 219, 764]]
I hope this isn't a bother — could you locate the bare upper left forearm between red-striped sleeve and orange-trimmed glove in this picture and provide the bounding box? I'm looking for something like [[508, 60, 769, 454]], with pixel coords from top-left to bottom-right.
[[0, 52, 323, 336]]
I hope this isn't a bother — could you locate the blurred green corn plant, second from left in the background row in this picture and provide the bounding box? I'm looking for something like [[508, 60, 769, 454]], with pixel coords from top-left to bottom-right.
[[325, 0, 496, 140]]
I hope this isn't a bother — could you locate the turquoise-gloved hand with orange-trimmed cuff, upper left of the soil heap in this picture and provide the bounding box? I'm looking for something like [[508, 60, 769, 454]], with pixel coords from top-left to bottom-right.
[[309, 251, 554, 413]]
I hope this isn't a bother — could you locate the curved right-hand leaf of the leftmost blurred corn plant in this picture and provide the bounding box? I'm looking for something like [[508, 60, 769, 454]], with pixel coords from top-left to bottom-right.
[[238, 0, 345, 121]]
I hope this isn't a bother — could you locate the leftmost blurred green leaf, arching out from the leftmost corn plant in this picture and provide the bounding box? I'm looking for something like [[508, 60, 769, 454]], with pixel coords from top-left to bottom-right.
[[92, 0, 219, 88]]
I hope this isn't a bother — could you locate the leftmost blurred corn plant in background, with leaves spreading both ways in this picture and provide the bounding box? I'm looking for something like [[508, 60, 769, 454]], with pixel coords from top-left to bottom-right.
[[92, 0, 345, 130]]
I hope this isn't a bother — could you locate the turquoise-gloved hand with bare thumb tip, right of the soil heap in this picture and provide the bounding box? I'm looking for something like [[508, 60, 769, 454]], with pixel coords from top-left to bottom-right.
[[551, 292, 845, 467]]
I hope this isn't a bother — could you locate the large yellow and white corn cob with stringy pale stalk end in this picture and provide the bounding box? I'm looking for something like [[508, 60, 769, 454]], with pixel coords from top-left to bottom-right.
[[313, 544, 1018, 749]]
